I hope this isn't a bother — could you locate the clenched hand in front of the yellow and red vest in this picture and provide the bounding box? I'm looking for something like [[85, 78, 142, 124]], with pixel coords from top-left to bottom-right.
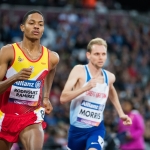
[[15, 68, 32, 81]]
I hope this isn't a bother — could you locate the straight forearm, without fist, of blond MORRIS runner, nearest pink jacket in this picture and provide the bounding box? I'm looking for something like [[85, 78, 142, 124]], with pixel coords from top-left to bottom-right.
[[109, 87, 124, 117]]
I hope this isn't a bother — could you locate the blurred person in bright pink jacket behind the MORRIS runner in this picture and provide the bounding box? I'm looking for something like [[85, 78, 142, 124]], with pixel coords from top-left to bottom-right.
[[117, 100, 145, 150]]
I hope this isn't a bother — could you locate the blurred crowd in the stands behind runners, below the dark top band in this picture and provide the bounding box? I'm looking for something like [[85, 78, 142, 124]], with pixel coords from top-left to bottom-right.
[[0, 4, 150, 150]]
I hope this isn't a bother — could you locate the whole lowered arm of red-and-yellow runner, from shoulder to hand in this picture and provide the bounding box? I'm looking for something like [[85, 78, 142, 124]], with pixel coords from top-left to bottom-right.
[[43, 51, 59, 114]]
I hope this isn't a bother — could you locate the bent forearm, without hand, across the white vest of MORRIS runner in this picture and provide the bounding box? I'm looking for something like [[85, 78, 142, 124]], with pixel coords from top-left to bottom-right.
[[60, 87, 87, 104]]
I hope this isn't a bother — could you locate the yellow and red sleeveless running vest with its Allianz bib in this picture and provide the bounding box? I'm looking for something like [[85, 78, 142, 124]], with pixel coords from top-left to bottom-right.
[[0, 43, 49, 114]]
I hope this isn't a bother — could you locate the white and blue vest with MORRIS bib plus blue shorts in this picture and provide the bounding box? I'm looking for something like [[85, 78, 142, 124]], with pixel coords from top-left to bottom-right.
[[68, 65, 109, 150]]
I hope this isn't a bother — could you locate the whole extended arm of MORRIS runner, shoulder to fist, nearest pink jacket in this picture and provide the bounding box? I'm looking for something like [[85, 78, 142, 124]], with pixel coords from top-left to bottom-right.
[[108, 72, 132, 125]]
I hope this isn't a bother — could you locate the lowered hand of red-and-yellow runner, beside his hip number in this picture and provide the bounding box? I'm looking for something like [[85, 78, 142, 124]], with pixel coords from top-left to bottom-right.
[[43, 98, 53, 114]]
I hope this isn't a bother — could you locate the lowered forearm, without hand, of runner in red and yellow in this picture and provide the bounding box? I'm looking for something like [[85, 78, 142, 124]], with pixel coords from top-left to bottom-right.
[[43, 68, 56, 99]]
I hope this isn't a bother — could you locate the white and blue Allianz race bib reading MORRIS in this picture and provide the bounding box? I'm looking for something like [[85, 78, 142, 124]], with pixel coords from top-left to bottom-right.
[[77, 100, 105, 126]]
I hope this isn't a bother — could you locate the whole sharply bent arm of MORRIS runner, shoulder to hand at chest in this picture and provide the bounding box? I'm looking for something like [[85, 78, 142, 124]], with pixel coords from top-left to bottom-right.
[[60, 65, 96, 104]]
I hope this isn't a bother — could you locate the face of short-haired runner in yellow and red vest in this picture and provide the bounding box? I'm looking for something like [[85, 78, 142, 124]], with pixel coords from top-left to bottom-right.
[[21, 13, 44, 40]]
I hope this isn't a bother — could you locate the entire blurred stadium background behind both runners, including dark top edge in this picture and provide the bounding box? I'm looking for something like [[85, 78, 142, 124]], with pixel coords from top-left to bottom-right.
[[0, 0, 150, 150]]
